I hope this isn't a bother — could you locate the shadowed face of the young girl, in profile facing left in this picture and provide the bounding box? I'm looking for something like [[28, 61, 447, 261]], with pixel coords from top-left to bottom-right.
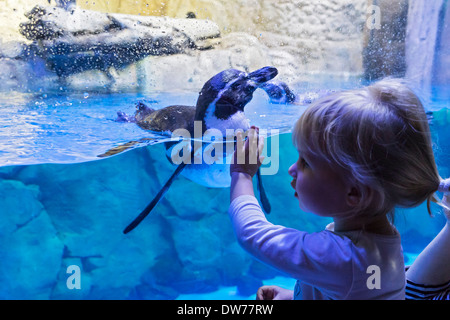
[[289, 150, 352, 218]]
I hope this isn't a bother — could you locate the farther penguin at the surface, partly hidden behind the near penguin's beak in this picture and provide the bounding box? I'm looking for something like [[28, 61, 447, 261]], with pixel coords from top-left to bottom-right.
[[260, 81, 335, 105]]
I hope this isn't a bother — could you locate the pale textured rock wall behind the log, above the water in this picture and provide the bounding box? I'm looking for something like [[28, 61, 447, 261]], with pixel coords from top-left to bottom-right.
[[0, 0, 450, 92]]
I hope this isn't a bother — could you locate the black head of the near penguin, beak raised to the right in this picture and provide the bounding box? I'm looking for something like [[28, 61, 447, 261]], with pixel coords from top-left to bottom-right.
[[195, 67, 278, 120]]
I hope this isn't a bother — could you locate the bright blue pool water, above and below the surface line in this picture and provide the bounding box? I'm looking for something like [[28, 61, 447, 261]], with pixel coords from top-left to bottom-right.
[[0, 83, 450, 299]]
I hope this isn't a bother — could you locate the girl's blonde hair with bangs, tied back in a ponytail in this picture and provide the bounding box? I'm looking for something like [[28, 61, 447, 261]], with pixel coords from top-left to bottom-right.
[[293, 79, 441, 215]]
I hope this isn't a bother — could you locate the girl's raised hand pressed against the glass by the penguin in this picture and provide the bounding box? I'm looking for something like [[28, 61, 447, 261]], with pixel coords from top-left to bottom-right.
[[230, 126, 264, 177]]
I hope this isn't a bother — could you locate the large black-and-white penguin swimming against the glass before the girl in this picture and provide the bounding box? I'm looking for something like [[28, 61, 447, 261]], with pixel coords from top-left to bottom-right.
[[122, 67, 278, 233]]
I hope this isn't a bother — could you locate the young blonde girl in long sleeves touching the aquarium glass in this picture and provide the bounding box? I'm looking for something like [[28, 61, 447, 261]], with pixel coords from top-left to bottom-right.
[[229, 80, 441, 299]]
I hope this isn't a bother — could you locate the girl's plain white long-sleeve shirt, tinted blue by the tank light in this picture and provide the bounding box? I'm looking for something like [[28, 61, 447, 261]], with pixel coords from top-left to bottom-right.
[[228, 195, 405, 300]]
